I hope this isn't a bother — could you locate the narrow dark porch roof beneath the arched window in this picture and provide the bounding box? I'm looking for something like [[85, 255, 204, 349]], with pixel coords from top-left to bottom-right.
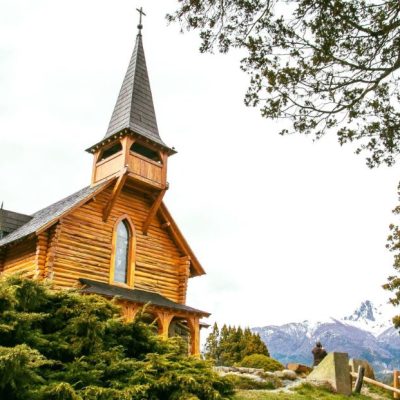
[[79, 278, 210, 317]]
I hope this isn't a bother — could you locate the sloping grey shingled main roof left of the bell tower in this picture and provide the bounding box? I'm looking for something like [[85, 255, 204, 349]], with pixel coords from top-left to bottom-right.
[[0, 181, 110, 247]]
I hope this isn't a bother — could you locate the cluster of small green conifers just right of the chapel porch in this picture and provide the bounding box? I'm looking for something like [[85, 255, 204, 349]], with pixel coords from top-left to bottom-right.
[[205, 323, 269, 366]]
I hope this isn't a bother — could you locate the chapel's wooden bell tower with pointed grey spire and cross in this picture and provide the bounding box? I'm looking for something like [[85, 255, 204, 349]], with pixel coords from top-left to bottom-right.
[[87, 8, 176, 192]]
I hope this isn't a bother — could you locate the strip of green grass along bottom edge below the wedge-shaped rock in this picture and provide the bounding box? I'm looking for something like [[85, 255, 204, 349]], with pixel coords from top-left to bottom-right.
[[233, 383, 392, 400]]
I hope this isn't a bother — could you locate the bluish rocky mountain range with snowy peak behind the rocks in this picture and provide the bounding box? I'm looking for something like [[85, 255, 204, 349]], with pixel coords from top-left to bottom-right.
[[252, 300, 400, 373]]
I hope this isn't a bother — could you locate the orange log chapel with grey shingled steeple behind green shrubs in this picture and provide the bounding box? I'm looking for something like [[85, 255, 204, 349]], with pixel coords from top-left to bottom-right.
[[0, 18, 209, 354]]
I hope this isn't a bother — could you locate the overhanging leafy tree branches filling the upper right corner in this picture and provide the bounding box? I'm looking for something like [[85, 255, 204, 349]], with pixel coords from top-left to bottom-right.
[[167, 0, 400, 167]]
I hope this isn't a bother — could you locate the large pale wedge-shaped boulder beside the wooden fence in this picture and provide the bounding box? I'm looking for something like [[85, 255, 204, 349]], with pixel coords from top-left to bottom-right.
[[307, 352, 351, 396]]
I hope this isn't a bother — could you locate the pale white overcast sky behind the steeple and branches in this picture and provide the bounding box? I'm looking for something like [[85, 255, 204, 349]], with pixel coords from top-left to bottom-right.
[[0, 0, 400, 327]]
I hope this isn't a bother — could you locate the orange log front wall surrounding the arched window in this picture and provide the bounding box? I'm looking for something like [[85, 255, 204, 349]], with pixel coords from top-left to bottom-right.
[[49, 188, 189, 303]]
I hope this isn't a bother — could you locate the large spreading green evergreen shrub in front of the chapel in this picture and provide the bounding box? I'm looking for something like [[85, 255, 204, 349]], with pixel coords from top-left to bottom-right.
[[0, 276, 232, 400]]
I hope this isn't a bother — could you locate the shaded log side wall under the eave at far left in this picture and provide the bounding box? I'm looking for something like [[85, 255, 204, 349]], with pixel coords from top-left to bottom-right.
[[2, 238, 36, 278]]
